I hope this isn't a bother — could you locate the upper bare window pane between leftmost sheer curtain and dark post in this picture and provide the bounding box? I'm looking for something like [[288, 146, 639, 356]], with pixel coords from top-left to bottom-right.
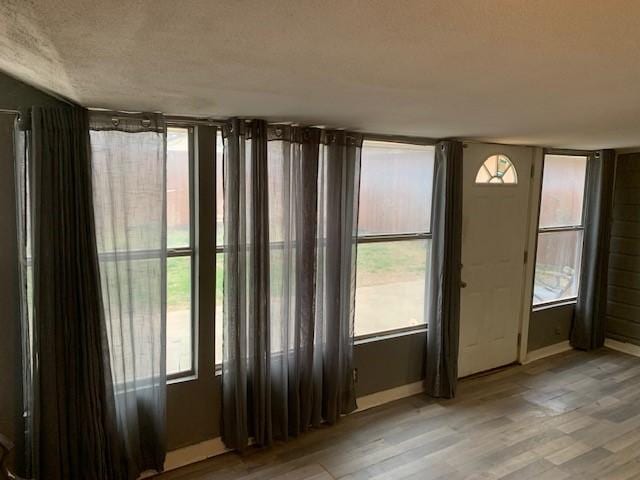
[[167, 128, 191, 248]]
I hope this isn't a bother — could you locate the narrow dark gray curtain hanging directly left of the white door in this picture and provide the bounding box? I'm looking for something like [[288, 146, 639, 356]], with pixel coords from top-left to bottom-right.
[[425, 141, 462, 398]]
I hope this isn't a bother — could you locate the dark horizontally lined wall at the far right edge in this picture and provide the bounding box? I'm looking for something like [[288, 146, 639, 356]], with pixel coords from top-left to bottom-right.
[[606, 153, 640, 345]]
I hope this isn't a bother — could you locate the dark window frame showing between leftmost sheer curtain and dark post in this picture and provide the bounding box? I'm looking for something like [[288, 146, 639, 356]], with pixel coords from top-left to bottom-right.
[[165, 125, 197, 383]]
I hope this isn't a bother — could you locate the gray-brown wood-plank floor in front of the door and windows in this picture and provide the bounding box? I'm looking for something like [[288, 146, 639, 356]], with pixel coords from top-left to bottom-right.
[[157, 349, 640, 480]]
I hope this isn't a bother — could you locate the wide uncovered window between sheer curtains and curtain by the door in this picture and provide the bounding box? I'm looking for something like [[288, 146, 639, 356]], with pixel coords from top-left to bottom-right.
[[355, 141, 434, 337]]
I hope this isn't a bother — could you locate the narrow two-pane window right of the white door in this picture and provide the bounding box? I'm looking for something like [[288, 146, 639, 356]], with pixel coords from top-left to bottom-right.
[[533, 154, 587, 306]]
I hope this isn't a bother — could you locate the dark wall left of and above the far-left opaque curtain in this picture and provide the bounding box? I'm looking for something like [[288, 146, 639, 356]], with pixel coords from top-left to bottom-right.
[[0, 73, 65, 464]]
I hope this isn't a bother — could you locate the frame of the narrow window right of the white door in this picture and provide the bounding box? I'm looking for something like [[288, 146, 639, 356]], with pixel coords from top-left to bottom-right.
[[531, 148, 597, 311]]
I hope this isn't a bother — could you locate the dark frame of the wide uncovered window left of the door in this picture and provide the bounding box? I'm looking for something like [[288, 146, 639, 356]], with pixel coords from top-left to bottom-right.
[[353, 134, 437, 345]]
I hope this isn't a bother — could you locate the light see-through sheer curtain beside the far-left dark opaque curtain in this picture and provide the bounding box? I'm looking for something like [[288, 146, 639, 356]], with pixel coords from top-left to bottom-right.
[[90, 112, 167, 478]]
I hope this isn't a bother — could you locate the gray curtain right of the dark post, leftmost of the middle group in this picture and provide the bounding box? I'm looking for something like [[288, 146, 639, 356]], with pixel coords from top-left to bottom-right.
[[222, 119, 273, 449]]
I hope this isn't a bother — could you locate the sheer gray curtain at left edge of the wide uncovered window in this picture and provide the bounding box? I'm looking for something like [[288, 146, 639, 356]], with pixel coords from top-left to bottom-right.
[[315, 131, 362, 423]]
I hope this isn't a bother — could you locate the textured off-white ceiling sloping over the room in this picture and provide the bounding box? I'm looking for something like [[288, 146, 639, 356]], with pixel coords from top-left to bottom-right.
[[0, 0, 640, 148]]
